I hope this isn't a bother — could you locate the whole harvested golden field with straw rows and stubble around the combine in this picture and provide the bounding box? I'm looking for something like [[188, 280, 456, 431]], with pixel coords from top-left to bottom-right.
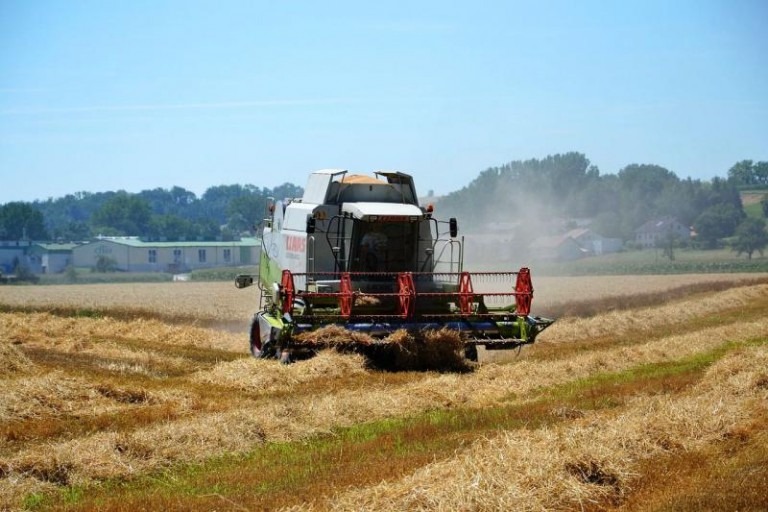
[[0, 275, 768, 510]]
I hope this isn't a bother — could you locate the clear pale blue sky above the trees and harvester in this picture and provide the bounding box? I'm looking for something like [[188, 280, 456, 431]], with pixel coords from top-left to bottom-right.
[[0, 0, 768, 204]]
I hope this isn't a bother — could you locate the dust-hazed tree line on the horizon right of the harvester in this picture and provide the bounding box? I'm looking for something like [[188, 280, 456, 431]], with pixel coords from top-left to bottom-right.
[[439, 152, 768, 252]]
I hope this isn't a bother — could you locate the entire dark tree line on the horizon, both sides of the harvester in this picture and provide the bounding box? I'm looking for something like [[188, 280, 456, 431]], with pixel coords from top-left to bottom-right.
[[0, 152, 768, 254]]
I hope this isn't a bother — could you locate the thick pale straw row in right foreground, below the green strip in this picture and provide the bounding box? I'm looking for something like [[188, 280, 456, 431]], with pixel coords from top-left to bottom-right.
[[291, 347, 768, 510]]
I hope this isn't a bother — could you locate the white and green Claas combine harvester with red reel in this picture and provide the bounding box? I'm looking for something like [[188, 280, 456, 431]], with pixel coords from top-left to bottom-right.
[[235, 170, 552, 362]]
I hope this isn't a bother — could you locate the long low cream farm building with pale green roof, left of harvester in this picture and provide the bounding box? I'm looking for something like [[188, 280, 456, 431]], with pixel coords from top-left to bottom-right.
[[73, 237, 260, 273]]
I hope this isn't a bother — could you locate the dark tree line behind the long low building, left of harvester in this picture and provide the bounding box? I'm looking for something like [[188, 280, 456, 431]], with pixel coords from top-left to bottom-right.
[[0, 183, 303, 241]]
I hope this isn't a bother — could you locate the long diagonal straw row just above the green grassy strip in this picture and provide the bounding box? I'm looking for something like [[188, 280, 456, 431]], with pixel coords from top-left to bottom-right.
[[6, 319, 768, 488]]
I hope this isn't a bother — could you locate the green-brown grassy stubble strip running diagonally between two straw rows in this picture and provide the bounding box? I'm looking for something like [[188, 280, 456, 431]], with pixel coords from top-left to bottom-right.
[[26, 339, 768, 510]]
